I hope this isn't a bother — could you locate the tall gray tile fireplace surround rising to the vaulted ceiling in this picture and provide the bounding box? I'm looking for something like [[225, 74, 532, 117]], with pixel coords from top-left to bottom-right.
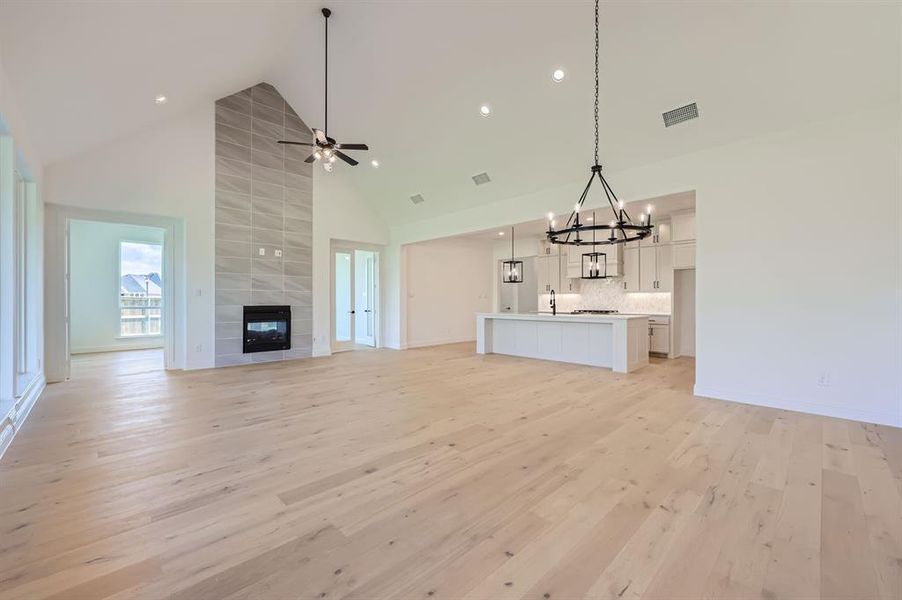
[[215, 83, 313, 367]]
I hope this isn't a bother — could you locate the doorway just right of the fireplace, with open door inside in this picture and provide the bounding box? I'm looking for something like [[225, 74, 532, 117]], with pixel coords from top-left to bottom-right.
[[331, 245, 379, 352]]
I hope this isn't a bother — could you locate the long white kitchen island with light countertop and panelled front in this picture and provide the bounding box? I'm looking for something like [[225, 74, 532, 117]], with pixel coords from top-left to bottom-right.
[[476, 313, 648, 373]]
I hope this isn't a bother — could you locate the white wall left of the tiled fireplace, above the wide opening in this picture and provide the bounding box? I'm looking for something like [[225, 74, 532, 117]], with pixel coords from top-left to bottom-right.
[[45, 101, 214, 369]]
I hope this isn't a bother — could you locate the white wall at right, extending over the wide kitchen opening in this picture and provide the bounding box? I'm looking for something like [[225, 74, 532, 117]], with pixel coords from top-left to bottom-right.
[[388, 103, 902, 426]]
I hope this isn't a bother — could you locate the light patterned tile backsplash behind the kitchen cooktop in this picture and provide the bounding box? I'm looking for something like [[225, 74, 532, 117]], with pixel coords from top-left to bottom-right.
[[539, 278, 670, 315]]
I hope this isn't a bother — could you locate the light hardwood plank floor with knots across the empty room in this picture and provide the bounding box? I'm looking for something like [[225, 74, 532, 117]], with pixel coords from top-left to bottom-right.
[[0, 344, 902, 600]]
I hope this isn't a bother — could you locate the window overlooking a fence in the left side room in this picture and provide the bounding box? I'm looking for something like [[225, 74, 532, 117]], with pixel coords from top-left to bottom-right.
[[119, 242, 163, 337]]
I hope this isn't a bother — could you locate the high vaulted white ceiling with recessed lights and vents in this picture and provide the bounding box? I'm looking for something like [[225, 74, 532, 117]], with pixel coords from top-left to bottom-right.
[[0, 0, 900, 221]]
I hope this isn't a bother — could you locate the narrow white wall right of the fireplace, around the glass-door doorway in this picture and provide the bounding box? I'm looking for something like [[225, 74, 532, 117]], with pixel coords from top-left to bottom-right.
[[313, 171, 388, 356]]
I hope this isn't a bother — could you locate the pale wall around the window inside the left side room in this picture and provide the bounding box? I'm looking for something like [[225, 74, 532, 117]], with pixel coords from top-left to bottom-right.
[[69, 220, 163, 353]]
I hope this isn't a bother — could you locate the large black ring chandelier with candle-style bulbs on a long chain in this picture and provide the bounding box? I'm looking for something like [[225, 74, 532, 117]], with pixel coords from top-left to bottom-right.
[[546, 0, 652, 248]]
